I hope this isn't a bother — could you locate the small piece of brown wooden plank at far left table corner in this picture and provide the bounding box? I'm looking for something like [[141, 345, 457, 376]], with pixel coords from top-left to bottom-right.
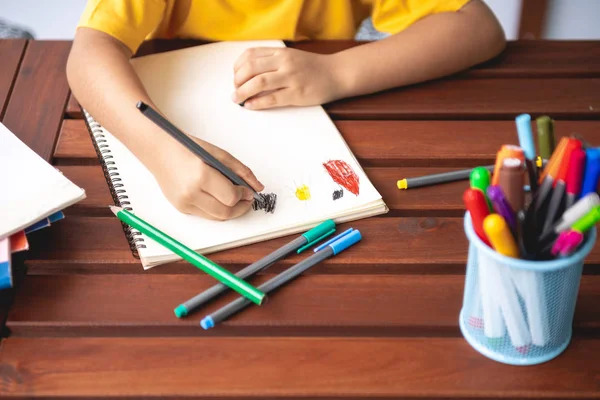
[[0, 39, 27, 121]]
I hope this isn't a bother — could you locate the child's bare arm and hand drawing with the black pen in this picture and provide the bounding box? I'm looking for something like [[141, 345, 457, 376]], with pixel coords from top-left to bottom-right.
[[67, 28, 263, 220]]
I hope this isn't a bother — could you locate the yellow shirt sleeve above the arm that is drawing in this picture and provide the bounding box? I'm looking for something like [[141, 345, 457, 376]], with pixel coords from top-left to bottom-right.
[[77, 0, 166, 53]]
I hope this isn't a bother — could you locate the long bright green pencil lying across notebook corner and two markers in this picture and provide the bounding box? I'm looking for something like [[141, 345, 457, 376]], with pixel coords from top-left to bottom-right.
[[110, 206, 265, 305]]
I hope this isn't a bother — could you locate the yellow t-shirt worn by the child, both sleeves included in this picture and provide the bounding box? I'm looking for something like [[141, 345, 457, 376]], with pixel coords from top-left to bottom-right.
[[78, 0, 469, 52]]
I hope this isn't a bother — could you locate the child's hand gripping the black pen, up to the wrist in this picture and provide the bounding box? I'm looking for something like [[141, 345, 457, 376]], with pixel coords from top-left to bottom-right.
[[149, 138, 264, 221]]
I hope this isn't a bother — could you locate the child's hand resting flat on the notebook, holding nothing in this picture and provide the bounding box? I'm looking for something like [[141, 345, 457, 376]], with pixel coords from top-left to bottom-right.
[[233, 47, 342, 110]]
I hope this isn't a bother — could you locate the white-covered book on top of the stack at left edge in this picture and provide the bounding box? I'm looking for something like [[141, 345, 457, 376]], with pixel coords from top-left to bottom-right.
[[0, 123, 85, 238]]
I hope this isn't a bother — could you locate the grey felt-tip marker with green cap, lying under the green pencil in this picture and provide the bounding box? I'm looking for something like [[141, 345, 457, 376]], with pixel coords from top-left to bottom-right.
[[174, 219, 335, 318]]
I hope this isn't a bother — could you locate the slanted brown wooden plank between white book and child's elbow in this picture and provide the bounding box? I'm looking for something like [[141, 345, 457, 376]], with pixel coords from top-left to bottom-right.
[[4, 41, 71, 161]]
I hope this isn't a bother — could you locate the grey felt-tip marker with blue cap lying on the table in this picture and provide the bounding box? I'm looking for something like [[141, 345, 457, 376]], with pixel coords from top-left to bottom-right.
[[200, 228, 362, 329]]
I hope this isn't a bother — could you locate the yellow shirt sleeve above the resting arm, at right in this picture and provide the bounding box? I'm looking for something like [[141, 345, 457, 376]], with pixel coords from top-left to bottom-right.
[[372, 0, 470, 34]]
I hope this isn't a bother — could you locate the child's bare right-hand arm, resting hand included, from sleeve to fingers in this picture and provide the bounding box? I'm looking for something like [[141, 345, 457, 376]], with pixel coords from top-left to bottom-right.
[[233, 0, 505, 109]]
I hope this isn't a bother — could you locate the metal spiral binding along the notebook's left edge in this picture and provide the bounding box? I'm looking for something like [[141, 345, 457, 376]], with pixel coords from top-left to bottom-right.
[[83, 110, 146, 258]]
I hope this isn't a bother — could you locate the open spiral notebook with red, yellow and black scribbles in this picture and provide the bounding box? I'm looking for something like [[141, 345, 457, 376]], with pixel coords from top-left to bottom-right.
[[84, 41, 388, 268]]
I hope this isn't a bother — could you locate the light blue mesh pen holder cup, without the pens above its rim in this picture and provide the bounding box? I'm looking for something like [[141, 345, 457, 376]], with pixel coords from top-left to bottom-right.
[[459, 212, 596, 365]]
